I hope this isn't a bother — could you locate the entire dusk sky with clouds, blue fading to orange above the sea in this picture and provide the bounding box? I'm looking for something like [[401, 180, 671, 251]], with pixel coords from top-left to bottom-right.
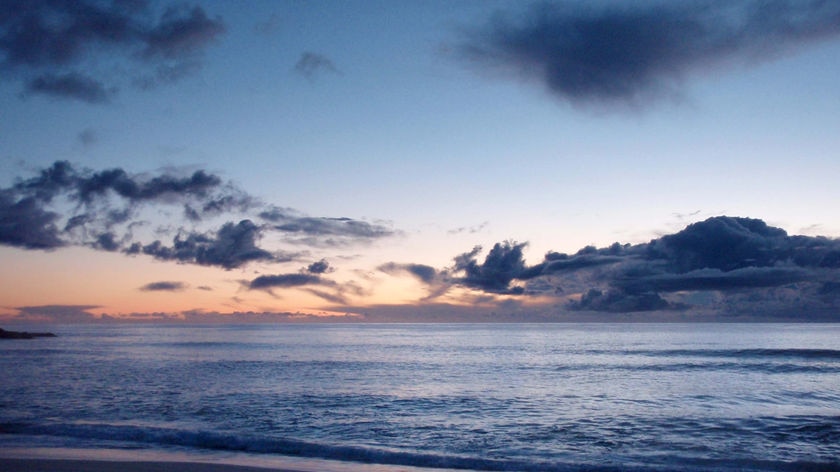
[[0, 0, 840, 322]]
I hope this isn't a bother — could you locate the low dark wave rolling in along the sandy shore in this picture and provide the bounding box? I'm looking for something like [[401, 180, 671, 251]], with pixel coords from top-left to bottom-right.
[[0, 422, 840, 472]]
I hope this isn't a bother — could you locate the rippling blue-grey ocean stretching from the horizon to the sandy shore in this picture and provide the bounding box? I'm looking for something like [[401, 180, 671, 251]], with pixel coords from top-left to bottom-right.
[[0, 324, 840, 471]]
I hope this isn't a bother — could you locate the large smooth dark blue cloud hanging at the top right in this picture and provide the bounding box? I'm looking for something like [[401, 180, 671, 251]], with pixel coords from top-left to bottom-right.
[[459, 0, 840, 107]]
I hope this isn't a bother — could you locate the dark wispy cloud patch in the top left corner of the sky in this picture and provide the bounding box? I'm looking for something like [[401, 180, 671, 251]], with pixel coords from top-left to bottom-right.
[[0, 0, 225, 104]]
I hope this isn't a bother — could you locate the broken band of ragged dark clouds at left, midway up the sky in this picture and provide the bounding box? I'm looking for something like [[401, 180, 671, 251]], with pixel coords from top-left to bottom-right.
[[0, 161, 395, 273]]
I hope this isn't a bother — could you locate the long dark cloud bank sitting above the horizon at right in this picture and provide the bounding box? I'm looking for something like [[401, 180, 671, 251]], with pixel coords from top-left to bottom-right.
[[379, 216, 840, 316]]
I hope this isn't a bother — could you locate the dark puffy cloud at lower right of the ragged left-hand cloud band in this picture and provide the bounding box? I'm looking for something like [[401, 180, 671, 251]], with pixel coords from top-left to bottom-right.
[[133, 220, 280, 269]]
